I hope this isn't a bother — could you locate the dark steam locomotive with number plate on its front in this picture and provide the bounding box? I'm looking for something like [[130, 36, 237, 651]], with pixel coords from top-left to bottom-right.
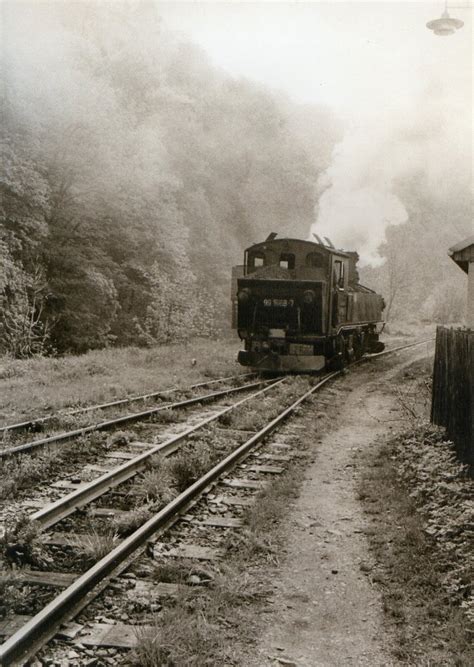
[[232, 233, 385, 372]]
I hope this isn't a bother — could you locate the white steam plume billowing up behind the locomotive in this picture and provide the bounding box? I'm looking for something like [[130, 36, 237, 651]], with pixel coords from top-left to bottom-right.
[[311, 77, 472, 266]]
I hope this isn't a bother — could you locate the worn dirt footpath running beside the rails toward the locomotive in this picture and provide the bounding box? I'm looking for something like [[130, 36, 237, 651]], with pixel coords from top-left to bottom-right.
[[250, 349, 432, 667]]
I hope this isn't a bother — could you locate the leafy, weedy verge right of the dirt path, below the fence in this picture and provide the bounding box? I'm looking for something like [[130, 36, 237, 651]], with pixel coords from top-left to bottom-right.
[[359, 426, 474, 667]]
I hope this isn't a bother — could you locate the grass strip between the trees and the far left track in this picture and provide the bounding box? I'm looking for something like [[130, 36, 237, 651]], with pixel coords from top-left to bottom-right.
[[0, 339, 241, 424]]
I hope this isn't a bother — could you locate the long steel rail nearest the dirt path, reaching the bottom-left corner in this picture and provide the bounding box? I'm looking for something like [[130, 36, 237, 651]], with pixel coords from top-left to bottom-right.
[[0, 371, 341, 667]]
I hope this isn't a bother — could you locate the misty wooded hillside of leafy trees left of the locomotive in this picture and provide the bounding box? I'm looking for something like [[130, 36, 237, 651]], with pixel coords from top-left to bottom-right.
[[0, 3, 337, 356]]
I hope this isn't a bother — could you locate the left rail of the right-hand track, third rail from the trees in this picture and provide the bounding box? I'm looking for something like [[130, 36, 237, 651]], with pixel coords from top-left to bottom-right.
[[29, 378, 285, 528]]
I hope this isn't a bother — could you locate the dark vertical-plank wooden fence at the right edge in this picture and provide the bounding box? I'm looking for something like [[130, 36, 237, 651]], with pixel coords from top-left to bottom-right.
[[431, 327, 474, 465]]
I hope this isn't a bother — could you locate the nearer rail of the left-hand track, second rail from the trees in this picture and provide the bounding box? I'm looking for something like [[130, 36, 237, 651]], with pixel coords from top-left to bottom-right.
[[0, 380, 268, 459]]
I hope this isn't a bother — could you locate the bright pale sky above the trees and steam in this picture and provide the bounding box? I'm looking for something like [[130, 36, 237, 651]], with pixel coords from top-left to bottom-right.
[[157, 1, 472, 118]]
